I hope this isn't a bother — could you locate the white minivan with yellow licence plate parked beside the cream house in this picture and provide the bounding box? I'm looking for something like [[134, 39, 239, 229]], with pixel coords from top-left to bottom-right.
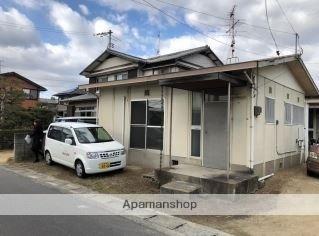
[[44, 122, 126, 177]]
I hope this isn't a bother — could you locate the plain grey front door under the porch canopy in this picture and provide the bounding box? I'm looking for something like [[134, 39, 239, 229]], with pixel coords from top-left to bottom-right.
[[203, 101, 227, 170]]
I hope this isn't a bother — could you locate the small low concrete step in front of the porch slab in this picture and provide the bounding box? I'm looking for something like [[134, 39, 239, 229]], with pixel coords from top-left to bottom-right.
[[160, 181, 201, 194]]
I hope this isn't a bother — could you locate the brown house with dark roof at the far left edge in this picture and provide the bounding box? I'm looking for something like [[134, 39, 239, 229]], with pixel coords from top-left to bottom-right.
[[0, 72, 47, 109]]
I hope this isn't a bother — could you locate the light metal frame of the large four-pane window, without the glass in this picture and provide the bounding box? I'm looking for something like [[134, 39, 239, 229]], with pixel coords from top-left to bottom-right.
[[129, 97, 165, 152]]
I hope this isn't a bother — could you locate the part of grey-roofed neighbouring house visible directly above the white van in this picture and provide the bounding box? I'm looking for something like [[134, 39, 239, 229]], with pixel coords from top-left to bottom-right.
[[53, 88, 97, 117]]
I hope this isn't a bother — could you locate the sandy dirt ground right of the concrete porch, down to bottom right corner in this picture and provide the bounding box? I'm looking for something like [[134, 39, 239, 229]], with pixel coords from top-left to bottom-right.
[[182, 166, 319, 236]]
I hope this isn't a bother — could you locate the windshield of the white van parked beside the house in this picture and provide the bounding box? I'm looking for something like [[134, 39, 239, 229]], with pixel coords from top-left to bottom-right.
[[74, 127, 113, 143]]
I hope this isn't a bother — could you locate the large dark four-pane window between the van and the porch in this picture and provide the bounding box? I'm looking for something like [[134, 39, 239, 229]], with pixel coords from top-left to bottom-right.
[[130, 99, 164, 150]]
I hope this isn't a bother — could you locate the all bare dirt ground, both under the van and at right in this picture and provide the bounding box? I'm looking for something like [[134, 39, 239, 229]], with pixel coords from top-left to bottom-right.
[[0, 151, 319, 236]]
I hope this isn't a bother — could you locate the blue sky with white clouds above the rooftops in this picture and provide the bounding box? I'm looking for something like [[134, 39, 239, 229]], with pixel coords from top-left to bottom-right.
[[0, 0, 319, 97]]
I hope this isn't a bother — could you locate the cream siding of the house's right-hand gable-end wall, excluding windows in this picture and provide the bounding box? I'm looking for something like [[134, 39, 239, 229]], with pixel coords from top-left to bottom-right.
[[254, 65, 305, 164]]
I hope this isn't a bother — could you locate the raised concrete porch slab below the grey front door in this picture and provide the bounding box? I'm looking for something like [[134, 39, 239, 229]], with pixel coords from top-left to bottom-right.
[[155, 164, 258, 194]]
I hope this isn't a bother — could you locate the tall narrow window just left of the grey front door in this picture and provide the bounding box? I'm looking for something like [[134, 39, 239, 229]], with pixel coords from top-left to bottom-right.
[[191, 92, 202, 157]]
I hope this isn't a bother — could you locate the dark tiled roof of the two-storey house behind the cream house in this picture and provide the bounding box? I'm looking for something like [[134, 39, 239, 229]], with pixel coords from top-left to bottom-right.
[[80, 45, 223, 75]]
